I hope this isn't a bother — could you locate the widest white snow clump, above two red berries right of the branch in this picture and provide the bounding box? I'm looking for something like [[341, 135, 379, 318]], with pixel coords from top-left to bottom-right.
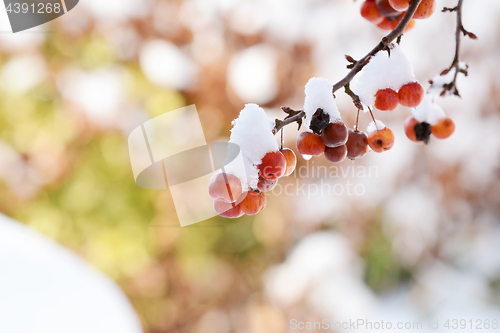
[[351, 44, 416, 107]]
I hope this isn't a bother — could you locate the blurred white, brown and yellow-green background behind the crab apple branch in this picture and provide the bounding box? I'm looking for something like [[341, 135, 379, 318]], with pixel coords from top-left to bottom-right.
[[0, 0, 500, 333]]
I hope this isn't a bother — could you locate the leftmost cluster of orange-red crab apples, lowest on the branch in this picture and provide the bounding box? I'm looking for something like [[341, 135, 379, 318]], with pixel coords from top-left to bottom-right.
[[208, 148, 297, 218]]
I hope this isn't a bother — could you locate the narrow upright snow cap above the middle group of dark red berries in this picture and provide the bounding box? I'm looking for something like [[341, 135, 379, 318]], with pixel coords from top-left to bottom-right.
[[304, 77, 342, 128]]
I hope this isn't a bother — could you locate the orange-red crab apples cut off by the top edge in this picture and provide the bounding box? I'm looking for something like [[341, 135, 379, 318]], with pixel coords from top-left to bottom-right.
[[361, 0, 436, 32]]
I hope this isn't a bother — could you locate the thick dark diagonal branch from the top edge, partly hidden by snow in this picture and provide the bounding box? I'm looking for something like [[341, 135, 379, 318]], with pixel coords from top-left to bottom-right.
[[273, 0, 422, 133]]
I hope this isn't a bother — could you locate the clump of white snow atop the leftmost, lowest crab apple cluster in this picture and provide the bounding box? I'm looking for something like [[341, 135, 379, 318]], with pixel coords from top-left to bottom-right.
[[225, 103, 279, 190]]
